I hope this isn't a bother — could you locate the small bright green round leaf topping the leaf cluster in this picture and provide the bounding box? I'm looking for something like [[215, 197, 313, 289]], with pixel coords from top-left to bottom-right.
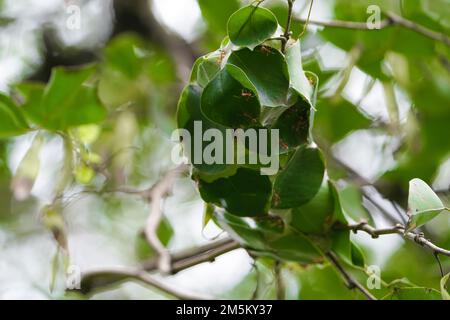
[[228, 6, 278, 48]]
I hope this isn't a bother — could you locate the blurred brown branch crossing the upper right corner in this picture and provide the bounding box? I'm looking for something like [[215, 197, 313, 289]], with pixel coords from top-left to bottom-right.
[[295, 12, 450, 46]]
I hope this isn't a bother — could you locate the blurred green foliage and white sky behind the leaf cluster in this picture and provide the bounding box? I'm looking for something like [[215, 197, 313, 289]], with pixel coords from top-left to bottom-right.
[[0, 0, 450, 299]]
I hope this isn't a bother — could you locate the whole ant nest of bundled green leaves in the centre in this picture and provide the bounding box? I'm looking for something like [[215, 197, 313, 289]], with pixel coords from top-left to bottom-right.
[[177, 3, 364, 265]]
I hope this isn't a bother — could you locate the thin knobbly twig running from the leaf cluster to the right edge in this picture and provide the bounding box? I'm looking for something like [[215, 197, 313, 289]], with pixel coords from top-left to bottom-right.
[[348, 221, 450, 257]]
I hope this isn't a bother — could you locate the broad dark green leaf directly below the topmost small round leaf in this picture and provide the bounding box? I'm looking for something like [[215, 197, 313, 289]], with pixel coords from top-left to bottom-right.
[[228, 46, 289, 107]]
